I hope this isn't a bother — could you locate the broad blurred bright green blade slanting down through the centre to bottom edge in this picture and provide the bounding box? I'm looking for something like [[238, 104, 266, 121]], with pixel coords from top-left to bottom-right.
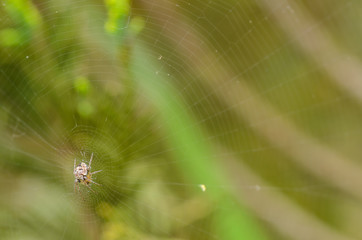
[[131, 45, 264, 240]]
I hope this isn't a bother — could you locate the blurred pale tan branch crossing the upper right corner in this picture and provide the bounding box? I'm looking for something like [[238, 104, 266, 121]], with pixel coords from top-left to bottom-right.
[[259, 0, 362, 104]]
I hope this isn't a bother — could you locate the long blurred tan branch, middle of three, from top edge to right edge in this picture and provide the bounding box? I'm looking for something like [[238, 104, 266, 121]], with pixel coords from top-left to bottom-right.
[[139, 1, 362, 200]]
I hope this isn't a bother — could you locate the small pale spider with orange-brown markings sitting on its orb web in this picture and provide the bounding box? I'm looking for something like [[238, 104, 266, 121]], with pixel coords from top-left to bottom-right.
[[73, 153, 102, 192]]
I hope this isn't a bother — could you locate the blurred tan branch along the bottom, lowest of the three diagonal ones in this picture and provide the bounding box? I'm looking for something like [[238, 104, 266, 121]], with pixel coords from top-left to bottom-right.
[[223, 152, 351, 240]]
